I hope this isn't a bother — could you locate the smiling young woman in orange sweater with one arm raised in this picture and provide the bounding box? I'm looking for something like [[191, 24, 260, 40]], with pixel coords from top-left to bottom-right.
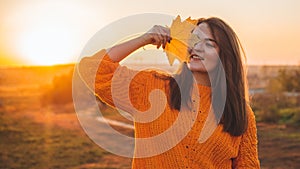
[[79, 17, 259, 169]]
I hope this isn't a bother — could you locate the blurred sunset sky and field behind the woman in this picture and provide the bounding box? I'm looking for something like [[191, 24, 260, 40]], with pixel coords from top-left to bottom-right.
[[0, 0, 300, 169]]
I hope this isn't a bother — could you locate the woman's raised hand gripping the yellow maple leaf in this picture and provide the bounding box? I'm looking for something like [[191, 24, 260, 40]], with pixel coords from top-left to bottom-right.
[[141, 25, 171, 49]]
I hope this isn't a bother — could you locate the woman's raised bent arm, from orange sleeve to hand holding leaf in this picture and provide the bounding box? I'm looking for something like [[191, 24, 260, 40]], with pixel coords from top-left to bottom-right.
[[78, 26, 170, 112]]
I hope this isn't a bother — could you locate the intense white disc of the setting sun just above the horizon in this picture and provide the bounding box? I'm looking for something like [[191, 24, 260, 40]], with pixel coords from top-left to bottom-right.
[[19, 24, 74, 65]]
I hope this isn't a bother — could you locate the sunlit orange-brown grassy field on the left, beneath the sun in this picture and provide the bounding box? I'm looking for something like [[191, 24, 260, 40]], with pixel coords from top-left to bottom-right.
[[0, 67, 131, 169]]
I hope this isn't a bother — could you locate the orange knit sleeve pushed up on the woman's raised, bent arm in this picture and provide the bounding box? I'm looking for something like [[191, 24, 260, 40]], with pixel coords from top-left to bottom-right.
[[78, 50, 166, 113]]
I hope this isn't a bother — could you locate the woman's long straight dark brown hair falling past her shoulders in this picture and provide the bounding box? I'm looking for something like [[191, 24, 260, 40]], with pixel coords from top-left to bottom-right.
[[169, 17, 248, 136]]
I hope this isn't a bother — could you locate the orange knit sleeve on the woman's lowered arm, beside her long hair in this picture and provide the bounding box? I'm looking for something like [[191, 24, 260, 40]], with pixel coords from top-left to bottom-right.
[[233, 106, 260, 169]]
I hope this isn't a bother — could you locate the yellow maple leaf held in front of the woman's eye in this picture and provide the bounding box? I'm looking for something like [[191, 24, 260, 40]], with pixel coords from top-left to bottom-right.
[[165, 15, 200, 65]]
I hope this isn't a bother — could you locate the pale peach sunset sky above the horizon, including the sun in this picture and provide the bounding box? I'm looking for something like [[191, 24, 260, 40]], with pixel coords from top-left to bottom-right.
[[0, 0, 300, 66]]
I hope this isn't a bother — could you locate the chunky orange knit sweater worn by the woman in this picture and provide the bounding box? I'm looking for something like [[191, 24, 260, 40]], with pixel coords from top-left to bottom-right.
[[79, 50, 260, 169]]
